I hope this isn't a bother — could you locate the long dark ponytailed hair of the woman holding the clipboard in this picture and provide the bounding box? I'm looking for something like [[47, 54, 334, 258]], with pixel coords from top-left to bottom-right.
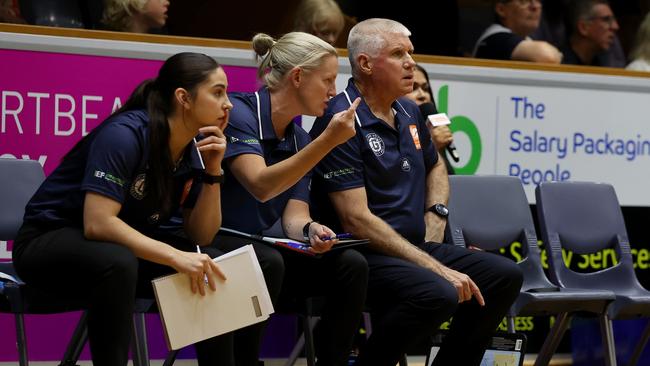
[[64, 52, 221, 214]]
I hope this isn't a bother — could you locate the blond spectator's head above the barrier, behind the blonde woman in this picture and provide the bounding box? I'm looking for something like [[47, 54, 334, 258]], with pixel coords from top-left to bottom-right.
[[294, 0, 345, 45]]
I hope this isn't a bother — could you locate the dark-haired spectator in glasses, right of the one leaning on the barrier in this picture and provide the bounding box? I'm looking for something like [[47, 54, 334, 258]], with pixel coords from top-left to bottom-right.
[[562, 0, 619, 67]]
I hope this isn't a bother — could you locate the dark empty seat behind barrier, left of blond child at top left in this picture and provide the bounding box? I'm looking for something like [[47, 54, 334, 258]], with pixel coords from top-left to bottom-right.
[[19, 0, 84, 28]]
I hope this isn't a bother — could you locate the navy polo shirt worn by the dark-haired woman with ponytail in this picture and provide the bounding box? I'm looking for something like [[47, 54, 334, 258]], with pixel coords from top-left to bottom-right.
[[25, 110, 204, 232]]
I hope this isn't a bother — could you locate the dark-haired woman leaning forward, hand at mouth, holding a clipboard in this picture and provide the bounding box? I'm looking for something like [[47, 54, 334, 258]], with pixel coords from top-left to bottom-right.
[[13, 53, 232, 365]]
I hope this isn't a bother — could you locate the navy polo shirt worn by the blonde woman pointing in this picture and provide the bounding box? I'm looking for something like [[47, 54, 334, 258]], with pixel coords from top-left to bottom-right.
[[221, 87, 311, 234]]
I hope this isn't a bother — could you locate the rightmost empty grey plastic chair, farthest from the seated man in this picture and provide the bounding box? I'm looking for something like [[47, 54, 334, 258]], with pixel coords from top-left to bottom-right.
[[535, 182, 650, 365]]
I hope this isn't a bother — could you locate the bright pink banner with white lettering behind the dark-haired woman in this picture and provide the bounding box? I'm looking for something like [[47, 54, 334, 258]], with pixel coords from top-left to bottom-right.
[[0, 50, 257, 361]]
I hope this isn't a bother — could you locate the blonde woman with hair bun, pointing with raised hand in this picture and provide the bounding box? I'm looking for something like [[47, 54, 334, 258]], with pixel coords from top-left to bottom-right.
[[215, 32, 368, 366]]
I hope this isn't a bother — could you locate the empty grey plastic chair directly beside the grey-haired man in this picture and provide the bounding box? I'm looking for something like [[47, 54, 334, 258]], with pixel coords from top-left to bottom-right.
[[447, 175, 615, 365]]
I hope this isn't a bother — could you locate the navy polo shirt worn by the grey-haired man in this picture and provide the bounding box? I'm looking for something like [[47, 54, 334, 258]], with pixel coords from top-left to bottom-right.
[[310, 79, 438, 243]]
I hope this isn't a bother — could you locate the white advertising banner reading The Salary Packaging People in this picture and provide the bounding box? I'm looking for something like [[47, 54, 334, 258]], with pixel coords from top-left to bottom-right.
[[410, 64, 650, 206]]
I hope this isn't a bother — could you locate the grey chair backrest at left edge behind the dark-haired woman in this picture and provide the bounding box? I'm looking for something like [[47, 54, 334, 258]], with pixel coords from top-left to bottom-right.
[[0, 158, 45, 240]]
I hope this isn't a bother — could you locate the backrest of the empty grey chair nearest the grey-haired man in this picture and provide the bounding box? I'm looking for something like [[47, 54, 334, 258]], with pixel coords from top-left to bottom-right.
[[447, 175, 555, 291]]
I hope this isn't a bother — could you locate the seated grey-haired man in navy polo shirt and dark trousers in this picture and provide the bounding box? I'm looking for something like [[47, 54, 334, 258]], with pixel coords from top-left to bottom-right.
[[310, 18, 522, 366]]
